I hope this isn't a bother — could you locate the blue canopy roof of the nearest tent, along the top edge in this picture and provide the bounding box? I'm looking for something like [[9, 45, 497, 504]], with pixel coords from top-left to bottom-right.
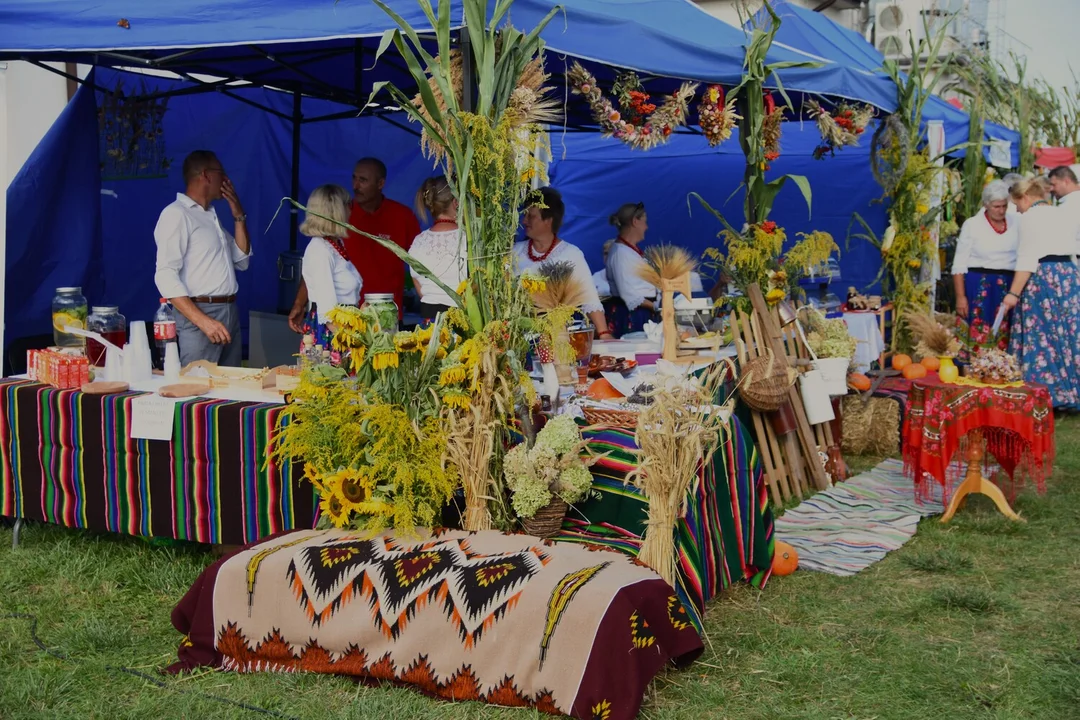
[[0, 0, 895, 111]]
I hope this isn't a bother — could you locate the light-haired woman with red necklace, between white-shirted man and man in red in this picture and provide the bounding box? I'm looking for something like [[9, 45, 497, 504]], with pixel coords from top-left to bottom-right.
[[300, 185, 363, 349]]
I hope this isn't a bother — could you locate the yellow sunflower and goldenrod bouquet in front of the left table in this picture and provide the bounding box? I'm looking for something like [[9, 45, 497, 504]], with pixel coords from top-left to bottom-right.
[[271, 305, 463, 532]]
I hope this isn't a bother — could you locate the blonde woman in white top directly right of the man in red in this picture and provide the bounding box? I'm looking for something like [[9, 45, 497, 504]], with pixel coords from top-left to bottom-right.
[[409, 176, 469, 320]]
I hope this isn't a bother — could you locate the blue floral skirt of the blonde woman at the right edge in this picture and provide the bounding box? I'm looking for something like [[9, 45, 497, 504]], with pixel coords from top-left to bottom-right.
[[1009, 261, 1080, 411]]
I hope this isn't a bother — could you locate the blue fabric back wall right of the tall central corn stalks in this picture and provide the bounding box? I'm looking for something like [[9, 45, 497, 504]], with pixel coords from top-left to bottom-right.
[[551, 122, 886, 295]]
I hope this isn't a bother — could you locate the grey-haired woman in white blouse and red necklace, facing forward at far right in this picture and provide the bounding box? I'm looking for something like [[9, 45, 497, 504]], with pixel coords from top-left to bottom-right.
[[953, 180, 1020, 350]]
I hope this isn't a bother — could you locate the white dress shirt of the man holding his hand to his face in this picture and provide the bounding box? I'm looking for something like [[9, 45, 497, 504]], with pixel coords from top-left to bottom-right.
[[153, 192, 252, 298]]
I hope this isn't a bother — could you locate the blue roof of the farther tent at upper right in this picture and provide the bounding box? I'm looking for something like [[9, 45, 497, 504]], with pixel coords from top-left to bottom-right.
[[748, 0, 1020, 166]]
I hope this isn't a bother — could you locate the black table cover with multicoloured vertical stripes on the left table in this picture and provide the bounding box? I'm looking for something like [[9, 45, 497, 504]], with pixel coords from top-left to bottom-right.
[[0, 380, 314, 545]]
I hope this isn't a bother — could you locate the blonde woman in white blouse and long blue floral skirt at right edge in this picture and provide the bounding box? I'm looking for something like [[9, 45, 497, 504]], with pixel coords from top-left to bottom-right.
[[1002, 179, 1080, 411]]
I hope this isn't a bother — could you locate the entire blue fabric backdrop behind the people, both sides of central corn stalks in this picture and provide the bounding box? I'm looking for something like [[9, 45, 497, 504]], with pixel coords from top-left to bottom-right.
[[6, 68, 885, 351]]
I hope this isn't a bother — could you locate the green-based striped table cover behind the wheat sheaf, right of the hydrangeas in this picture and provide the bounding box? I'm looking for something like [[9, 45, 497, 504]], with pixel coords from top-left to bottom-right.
[[555, 418, 773, 631]]
